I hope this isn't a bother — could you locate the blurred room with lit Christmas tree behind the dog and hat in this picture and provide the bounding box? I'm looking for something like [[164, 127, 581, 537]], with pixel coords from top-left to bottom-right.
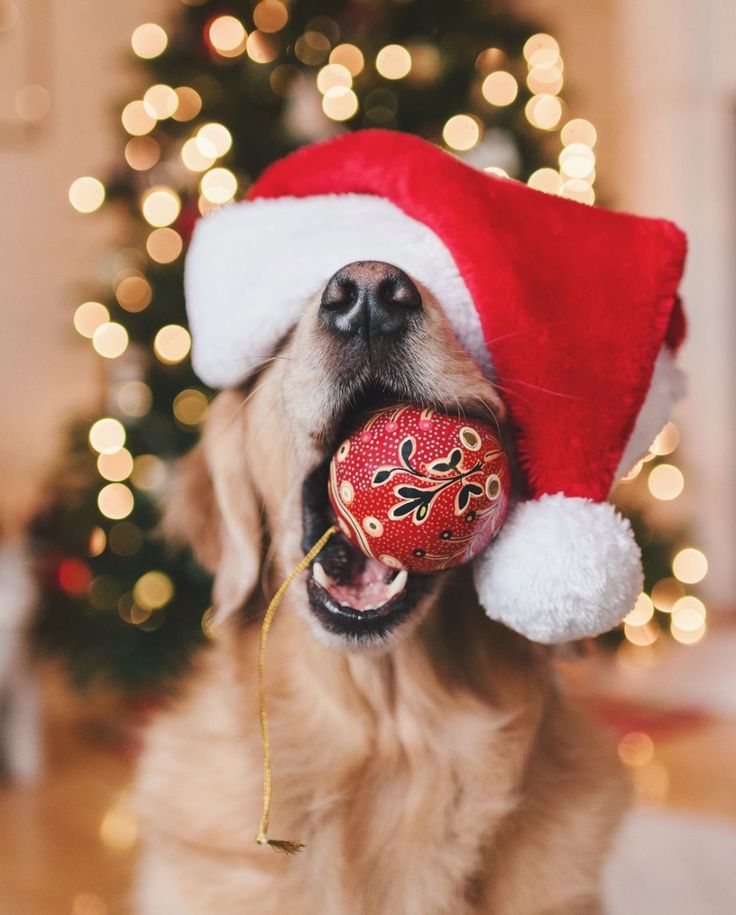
[[0, 0, 736, 915]]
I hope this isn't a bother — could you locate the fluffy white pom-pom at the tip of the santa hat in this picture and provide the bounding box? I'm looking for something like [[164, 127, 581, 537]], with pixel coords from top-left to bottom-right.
[[474, 493, 643, 643]]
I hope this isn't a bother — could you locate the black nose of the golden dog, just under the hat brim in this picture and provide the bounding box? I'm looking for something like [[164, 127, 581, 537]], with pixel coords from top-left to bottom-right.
[[320, 261, 422, 340]]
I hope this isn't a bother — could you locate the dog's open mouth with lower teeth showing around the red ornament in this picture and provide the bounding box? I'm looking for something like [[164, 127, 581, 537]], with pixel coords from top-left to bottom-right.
[[302, 391, 430, 641]]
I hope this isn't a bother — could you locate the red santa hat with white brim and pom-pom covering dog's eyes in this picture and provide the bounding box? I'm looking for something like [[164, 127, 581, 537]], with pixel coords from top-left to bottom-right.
[[186, 130, 686, 642]]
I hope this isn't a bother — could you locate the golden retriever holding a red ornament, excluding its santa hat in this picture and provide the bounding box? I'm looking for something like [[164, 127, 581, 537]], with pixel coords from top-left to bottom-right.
[[136, 262, 628, 915]]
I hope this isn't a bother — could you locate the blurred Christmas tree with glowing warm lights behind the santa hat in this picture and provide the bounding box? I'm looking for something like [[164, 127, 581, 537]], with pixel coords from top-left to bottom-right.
[[34, 0, 700, 691]]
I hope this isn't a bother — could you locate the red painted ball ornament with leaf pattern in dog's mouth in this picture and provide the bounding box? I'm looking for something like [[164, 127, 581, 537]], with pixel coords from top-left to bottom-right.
[[328, 404, 510, 572]]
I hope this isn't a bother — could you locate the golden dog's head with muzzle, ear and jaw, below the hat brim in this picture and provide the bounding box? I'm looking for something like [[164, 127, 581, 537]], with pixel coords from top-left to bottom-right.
[[166, 261, 503, 648]]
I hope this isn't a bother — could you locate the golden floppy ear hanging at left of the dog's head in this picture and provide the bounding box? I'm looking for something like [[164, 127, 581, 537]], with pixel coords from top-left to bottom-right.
[[162, 392, 261, 623]]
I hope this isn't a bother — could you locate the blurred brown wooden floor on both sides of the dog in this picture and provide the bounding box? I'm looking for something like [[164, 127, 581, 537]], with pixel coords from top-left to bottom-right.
[[0, 636, 736, 915]]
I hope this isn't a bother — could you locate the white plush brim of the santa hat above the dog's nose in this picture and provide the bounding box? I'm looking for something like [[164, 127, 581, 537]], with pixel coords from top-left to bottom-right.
[[185, 194, 490, 387]]
